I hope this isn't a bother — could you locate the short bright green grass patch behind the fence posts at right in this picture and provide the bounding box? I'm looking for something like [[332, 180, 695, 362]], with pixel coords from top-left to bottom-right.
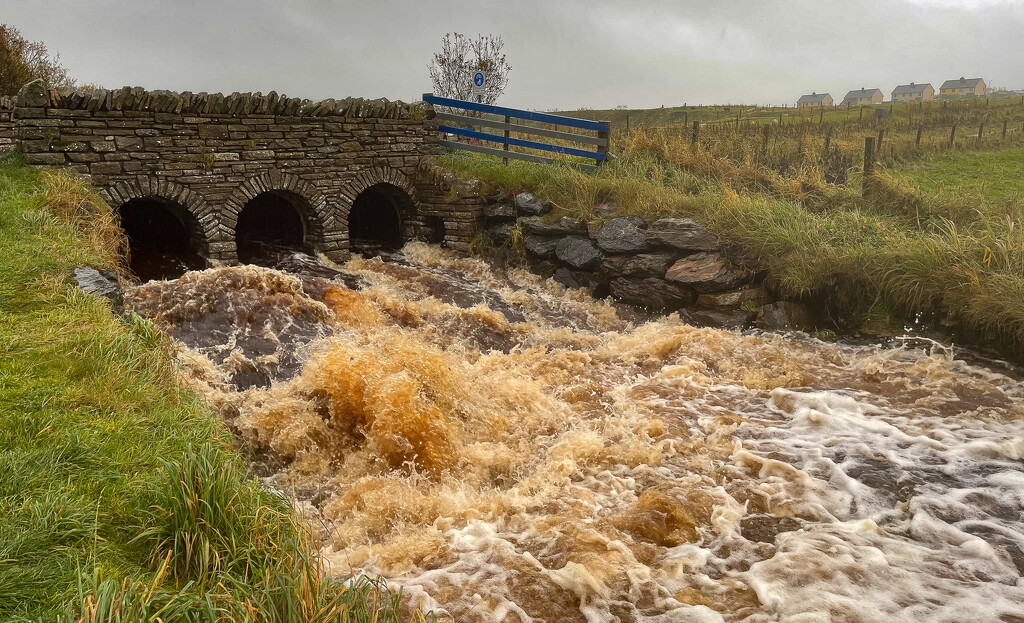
[[900, 148, 1024, 203]]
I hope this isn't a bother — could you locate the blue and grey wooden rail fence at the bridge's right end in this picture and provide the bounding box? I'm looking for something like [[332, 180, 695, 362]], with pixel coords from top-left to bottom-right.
[[423, 93, 610, 171]]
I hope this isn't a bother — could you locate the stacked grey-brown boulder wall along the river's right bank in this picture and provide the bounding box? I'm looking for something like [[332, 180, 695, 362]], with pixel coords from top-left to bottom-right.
[[484, 202, 812, 330]]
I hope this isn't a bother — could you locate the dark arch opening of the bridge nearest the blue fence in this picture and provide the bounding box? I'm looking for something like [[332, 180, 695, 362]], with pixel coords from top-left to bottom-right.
[[348, 183, 414, 255]]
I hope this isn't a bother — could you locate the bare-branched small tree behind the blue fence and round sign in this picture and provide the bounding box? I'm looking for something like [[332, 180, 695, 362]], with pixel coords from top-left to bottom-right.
[[430, 33, 512, 103]]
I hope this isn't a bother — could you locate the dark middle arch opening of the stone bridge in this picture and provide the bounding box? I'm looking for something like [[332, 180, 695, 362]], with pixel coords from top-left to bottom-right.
[[234, 191, 308, 264]]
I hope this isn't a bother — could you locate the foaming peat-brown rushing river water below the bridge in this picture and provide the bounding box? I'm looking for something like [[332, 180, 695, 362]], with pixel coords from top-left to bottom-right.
[[128, 243, 1024, 623]]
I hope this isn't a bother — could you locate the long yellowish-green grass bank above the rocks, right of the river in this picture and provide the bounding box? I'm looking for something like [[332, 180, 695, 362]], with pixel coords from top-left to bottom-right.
[[441, 129, 1024, 350]]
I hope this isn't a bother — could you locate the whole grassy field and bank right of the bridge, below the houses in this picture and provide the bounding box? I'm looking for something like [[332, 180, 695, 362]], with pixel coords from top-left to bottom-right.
[[441, 96, 1024, 354]]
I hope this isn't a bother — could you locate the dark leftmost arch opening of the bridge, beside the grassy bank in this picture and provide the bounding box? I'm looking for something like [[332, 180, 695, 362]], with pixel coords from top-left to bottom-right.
[[118, 197, 206, 281]]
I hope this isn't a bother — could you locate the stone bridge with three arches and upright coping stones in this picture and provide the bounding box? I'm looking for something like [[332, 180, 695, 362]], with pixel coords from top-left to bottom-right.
[[0, 81, 481, 270]]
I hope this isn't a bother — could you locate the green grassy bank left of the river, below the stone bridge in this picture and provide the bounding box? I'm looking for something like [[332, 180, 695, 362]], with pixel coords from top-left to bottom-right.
[[0, 151, 418, 621]]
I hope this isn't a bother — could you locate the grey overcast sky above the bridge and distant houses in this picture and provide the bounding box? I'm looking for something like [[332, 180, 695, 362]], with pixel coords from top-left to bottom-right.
[[8, 0, 1024, 110]]
